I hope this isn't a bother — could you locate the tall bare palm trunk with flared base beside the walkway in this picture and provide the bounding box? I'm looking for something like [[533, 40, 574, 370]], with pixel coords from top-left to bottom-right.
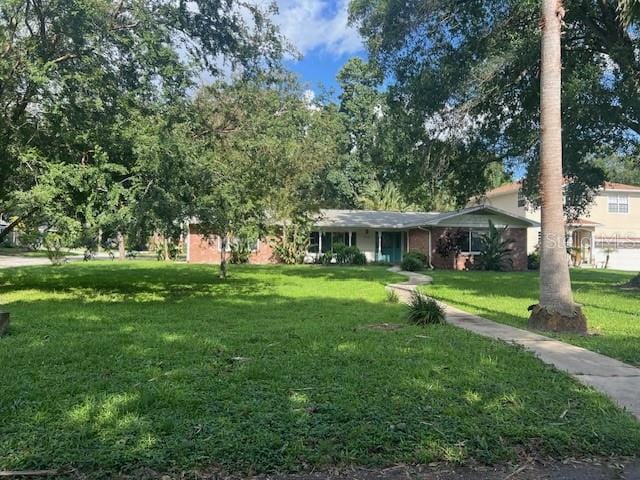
[[529, 0, 587, 332]]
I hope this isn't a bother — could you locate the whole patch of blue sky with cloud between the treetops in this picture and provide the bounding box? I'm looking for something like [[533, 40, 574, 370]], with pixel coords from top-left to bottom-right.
[[274, 0, 365, 93]]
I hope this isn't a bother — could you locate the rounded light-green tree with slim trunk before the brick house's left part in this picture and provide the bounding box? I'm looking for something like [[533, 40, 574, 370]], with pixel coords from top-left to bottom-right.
[[192, 76, 339, 277]]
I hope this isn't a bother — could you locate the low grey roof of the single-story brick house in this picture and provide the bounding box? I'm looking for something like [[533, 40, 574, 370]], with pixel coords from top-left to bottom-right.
[[314, 205, 539, 229]]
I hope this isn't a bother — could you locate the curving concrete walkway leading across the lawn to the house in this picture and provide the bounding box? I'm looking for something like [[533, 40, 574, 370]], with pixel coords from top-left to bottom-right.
[[387, 267, 640, 419]]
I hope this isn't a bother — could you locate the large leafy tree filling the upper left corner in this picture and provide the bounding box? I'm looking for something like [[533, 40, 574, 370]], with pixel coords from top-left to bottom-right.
[[0, 0, 284, 244]]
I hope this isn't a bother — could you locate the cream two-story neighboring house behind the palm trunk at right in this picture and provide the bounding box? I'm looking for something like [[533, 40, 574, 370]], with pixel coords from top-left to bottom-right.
[[472, 182, 640, 270]]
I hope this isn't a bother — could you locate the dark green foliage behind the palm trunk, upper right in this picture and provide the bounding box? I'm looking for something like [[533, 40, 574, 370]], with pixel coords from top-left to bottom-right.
[[350, 0, 640, 216]]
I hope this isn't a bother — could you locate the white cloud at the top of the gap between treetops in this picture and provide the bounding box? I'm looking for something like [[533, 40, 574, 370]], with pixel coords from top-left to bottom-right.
[[275, 0, 363, 56]]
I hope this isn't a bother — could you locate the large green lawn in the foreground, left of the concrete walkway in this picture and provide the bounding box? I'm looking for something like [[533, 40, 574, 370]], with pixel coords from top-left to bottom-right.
[[0, 262, 640, 477]]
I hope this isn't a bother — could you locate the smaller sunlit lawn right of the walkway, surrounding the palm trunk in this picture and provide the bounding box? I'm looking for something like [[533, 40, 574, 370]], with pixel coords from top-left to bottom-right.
[[424, 269, 640, 365]]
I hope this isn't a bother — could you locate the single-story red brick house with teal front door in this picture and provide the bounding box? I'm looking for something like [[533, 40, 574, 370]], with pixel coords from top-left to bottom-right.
[[187, 205, 539, 270]]
